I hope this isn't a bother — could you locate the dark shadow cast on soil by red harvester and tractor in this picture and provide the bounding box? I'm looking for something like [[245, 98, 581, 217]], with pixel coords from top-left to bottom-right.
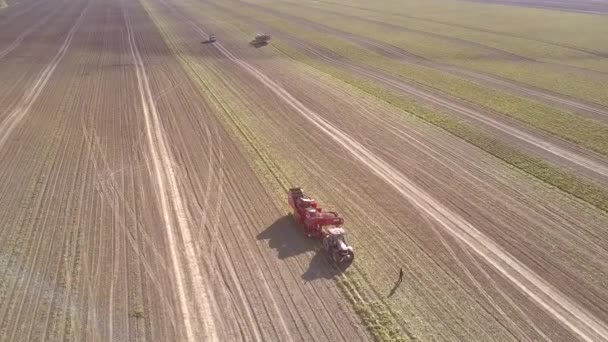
[[257, 215, 341, 281]]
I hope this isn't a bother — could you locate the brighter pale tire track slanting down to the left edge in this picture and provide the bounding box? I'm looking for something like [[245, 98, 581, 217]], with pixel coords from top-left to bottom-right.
[[0, 0, 93, 149]]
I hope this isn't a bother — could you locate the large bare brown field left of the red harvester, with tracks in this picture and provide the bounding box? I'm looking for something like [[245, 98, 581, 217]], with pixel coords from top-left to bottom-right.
[[0, 0, 368, 341]]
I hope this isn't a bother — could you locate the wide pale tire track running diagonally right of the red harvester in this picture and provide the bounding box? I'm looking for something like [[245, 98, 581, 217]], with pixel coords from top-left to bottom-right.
[[180, 21, 608, 341]]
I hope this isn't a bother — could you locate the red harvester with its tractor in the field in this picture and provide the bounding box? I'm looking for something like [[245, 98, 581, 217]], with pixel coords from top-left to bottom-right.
[[288, 188, 355, 265]]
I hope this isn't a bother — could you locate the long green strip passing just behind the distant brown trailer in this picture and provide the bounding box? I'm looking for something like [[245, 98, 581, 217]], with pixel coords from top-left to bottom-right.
[[206, 0, 608, 155]]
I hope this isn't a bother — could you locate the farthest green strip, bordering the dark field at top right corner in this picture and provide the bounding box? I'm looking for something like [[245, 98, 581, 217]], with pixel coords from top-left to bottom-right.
[[302, 0, 608, 53]]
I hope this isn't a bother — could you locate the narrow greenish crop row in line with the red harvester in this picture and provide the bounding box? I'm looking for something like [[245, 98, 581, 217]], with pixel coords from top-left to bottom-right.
[[142, 1, 410, 342]]
